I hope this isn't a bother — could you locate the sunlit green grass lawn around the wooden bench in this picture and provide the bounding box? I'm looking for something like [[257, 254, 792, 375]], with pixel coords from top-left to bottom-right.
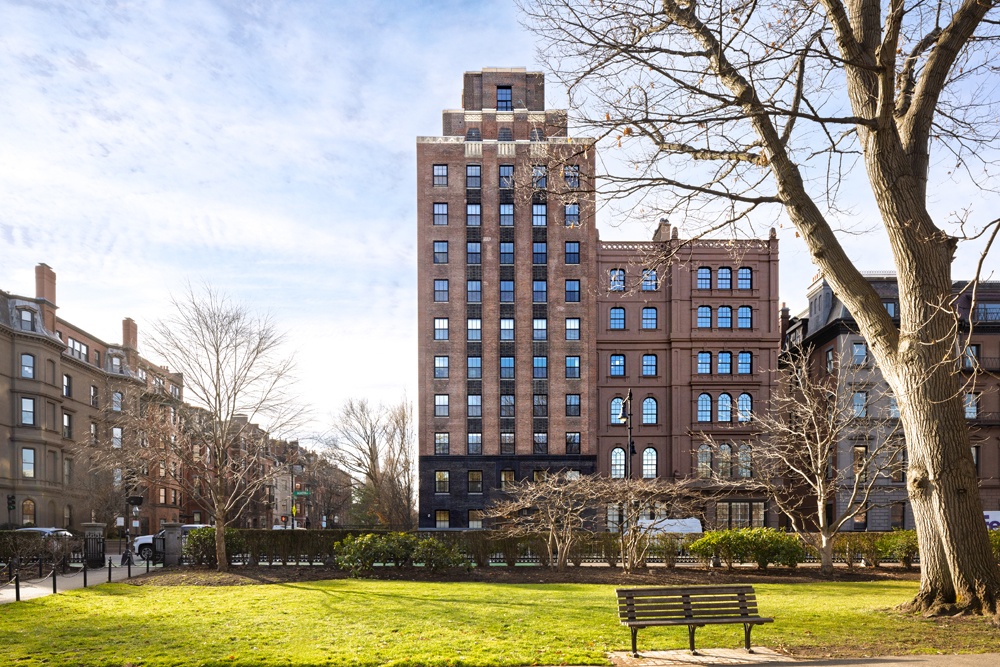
[[0, 580, 1000, 667]]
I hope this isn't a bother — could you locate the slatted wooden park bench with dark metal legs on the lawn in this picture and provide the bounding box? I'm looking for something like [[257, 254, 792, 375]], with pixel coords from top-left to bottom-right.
[[616, 586, 774, 657]]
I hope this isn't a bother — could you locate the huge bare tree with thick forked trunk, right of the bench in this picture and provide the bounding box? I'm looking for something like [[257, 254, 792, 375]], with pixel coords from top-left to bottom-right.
[[524, 0, 1000, 613]]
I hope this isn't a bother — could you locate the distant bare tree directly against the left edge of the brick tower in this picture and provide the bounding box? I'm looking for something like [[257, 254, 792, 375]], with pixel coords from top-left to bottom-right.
[[326, 398, 416, 530]]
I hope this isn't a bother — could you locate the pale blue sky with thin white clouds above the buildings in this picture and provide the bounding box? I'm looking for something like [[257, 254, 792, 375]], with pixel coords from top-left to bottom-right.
[[0, 0, 996, 444]]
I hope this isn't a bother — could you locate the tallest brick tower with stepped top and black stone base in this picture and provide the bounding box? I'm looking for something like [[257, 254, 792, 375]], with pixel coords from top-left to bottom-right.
[[417, 68, 598, 529]]
